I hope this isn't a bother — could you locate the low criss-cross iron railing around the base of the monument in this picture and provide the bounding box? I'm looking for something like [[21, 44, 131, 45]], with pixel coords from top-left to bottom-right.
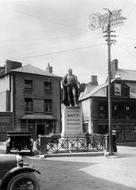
[[38, 135, 107, 154]]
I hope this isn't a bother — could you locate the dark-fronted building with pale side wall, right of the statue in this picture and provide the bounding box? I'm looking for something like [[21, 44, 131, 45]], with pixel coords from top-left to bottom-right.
[[80, 60, 136, 141]]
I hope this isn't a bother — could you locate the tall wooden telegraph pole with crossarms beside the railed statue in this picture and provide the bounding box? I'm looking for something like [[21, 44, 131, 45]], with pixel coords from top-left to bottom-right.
[[104, 9, 115, 155]]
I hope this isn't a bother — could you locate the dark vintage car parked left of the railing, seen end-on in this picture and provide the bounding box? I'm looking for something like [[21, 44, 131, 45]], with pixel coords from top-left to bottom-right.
[[5, 131, 33, 154]]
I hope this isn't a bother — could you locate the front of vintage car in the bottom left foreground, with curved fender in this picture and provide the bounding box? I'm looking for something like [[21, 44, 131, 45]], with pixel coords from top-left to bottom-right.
[[0, 154, 40, 190]]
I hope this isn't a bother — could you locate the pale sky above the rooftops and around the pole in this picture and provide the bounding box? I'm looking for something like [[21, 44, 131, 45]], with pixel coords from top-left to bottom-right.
[[0, 0, 136, 84]]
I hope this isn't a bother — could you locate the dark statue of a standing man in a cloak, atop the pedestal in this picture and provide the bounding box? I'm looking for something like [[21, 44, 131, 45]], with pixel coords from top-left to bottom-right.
[[62, 69, 80, 106]]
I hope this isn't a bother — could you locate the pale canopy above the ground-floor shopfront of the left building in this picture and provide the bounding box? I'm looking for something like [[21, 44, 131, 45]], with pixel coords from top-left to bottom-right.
[[21, 114, 55, 120]]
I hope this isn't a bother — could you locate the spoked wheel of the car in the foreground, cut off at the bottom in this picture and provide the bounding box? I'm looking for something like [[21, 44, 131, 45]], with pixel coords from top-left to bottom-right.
[[7, 173, 40, 190]]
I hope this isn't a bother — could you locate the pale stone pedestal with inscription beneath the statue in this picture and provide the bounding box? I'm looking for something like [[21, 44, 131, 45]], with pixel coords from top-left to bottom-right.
[[61, 106, 85, 138]]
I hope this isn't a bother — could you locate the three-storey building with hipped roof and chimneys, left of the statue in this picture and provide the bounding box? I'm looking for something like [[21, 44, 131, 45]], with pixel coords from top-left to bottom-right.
[[0, 60, 61, 139]]
